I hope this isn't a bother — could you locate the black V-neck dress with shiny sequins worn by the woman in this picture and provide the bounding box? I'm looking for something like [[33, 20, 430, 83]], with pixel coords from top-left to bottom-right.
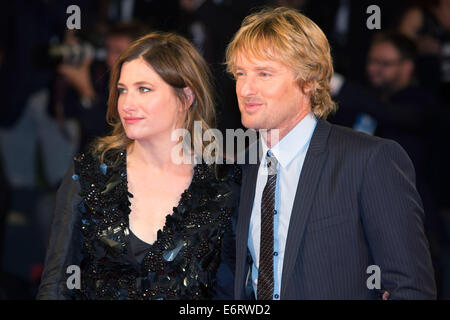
[[38, 152, 241, 300]]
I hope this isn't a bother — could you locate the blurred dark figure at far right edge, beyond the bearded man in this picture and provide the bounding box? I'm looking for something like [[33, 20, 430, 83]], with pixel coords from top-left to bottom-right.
[[398, 0, 450, 266]]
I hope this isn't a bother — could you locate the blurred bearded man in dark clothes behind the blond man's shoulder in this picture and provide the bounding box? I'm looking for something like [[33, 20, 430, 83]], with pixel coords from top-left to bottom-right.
[[331, 33, 446, 297]]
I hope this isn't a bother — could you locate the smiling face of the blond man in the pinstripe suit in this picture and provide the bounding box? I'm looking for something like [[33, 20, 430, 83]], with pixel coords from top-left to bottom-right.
[[234, 54, 311, 139]]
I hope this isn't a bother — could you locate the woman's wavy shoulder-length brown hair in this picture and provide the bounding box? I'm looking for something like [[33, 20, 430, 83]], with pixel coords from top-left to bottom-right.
[[91, 32, 216, 162]]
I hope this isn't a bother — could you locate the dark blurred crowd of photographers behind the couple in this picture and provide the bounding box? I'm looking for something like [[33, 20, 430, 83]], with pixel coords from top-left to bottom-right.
[[0, 0, 450, 299]]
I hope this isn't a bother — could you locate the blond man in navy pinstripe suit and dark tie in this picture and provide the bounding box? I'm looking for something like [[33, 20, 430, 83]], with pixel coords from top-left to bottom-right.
[[227, 8, 436, 299]]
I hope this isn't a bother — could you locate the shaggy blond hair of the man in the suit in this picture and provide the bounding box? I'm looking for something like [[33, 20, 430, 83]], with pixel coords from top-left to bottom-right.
[[226, 7, 337, 119]]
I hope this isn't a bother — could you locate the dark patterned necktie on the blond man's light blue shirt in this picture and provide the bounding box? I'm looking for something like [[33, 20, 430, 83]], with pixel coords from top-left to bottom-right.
[[257, 150, 278, 300]]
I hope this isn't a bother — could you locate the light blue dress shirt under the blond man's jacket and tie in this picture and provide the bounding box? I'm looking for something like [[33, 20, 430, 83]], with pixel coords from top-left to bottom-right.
[[248, 113, 317, 300]]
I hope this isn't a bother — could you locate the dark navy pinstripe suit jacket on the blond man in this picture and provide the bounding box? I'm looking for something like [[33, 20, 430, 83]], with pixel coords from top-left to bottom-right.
[[235, 120, 436, 299]]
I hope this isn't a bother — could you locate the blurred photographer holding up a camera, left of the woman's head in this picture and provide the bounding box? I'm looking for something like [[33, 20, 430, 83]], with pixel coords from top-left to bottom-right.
[[54, 22, 148, 151]]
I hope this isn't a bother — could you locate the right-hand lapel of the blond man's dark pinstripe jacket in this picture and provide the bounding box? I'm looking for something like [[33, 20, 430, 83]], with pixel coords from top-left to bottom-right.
[[281, 120, 331, 299]]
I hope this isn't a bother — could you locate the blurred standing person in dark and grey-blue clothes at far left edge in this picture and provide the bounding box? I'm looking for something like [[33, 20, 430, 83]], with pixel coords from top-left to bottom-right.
[[0, 0, 75, 298]]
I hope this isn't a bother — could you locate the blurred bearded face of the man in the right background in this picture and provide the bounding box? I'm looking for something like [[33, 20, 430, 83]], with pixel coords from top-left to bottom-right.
[[366, 42, 404, 89]]
